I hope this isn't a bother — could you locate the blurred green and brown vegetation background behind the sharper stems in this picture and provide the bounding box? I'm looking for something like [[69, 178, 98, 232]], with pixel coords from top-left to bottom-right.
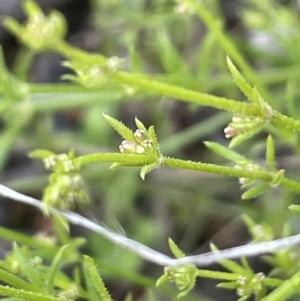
[[0, 0, 300, 301]]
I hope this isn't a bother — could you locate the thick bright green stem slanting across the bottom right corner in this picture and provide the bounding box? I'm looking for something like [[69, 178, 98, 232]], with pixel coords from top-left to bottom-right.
[[261, 272, 300, 301]]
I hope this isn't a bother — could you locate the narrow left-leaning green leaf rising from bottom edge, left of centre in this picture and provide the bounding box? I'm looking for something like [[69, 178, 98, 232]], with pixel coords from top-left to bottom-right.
[[83, 256, 113, 301]]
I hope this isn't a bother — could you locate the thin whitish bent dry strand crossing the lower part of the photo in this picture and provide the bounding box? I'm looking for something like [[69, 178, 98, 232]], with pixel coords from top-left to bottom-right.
[[0, 184, 300, 267]]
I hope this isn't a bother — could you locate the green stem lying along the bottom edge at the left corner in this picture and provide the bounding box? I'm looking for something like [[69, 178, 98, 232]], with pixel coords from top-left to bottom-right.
[[0, 285, 72, 301]]
